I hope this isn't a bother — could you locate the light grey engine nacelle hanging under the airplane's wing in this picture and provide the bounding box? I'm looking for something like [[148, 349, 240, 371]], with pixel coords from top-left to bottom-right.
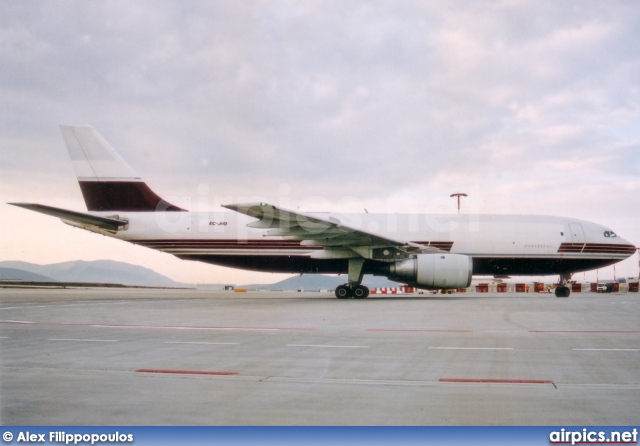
[[389, 254, 473, 290]]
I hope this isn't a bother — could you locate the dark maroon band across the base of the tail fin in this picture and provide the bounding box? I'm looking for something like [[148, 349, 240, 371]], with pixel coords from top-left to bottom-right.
[[79, 181, 185, 212]]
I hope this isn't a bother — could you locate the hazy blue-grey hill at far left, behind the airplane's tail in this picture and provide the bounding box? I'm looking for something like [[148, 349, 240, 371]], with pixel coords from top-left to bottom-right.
[[0, 260, 192, 288]]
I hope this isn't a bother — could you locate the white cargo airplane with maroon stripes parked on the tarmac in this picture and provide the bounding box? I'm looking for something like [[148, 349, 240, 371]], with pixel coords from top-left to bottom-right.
[[9, 126, 636, 299]]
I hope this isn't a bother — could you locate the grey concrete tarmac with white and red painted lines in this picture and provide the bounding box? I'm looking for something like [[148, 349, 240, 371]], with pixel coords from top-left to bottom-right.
[[0, 289, 640, 425]]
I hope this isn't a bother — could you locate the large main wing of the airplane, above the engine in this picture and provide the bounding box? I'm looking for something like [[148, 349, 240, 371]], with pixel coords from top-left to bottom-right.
[[223, 203, 441, 261]]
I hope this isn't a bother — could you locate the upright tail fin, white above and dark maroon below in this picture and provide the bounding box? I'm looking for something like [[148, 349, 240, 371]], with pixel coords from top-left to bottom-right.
[[60, 126, 184, 212]]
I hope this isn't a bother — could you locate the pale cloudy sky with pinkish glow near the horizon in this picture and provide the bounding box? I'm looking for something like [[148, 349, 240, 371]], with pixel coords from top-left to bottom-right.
[[0, 0, 640, 283]]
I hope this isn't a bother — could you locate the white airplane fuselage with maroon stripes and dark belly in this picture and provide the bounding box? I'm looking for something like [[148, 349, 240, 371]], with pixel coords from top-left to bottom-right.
[[85, 212, 635, 275]]
